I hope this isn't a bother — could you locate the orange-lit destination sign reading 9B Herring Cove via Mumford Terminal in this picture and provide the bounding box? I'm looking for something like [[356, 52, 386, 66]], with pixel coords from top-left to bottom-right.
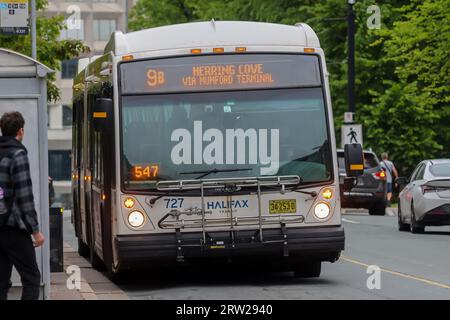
[[121, 54, 321, 94]]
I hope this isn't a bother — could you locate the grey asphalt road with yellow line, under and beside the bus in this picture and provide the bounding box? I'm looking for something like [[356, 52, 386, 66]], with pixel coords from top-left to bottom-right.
[[65, 212, 450, 300]]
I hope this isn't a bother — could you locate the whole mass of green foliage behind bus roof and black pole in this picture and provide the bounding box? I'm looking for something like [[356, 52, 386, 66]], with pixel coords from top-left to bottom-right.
[[130, 0, 450, 174]]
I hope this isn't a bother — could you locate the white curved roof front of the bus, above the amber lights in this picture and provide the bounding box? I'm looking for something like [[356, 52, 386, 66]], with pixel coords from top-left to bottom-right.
[[104, 20, 320, 55]]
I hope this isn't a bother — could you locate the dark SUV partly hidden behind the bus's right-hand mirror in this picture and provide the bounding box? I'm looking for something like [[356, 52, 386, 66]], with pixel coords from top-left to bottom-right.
[[337, 149, 386, 215]]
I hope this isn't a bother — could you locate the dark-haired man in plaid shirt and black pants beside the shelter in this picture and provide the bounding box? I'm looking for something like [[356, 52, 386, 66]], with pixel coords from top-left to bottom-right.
[[0, 112, 44, 300]]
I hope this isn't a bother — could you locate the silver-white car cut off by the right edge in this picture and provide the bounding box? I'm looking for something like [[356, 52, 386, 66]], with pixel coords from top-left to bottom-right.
[[397, 159, 450, 233]]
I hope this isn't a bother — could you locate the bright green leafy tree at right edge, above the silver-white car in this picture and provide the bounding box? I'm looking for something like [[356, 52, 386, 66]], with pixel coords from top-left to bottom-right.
[[364, 0, 450, 173]]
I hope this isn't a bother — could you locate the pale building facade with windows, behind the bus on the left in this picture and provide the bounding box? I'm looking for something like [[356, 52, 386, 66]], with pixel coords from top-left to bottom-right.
[[44, 0, 134, 208]]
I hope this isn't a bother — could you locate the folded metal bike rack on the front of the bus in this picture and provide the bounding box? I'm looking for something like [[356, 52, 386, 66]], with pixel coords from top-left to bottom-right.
[[156, 176, 305, 261]]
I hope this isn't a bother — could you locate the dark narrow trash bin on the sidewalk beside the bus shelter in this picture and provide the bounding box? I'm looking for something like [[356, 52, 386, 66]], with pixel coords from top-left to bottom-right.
[[50, 206, 64, 272]]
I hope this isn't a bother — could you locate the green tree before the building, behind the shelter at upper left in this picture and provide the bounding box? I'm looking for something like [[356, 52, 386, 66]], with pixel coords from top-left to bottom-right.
[[0, 0, 89, 101]]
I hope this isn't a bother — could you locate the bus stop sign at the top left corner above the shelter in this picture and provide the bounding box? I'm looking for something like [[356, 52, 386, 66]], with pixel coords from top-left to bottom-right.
[[0, 0, 28, 35]]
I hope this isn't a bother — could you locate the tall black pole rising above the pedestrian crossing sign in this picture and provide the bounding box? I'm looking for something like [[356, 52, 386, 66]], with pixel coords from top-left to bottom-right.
[[347, 3, 356, 112]]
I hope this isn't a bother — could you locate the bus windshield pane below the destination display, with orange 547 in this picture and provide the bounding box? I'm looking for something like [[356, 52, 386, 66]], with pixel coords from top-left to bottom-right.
[[121, 88, 332, 190]]
